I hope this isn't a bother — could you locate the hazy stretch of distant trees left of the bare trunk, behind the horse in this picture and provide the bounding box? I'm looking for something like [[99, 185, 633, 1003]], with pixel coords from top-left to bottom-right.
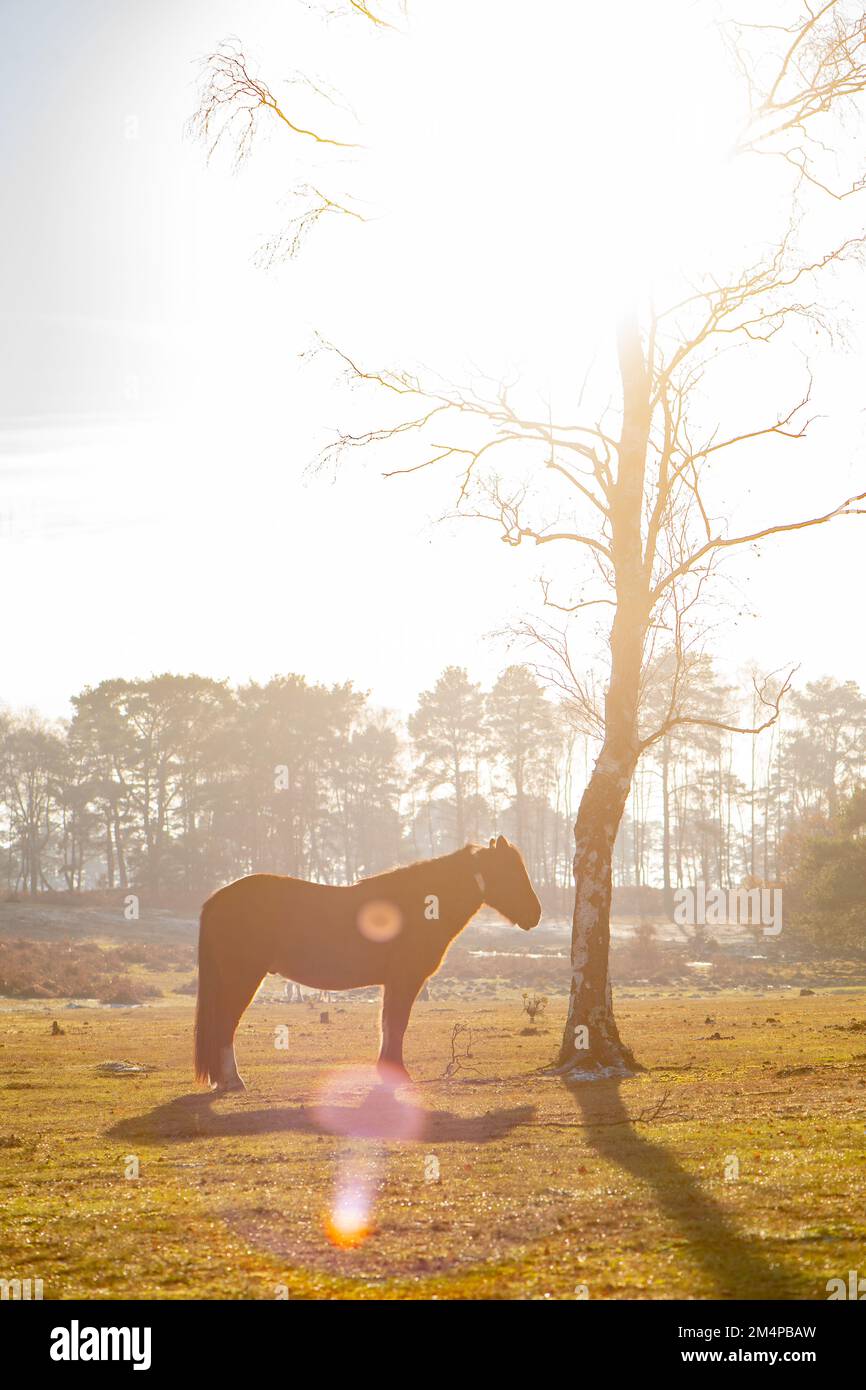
[[0, 666, 569, 898]]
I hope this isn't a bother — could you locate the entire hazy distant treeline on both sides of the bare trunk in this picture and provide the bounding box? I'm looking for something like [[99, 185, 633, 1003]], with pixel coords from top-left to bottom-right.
[[0, 664, 866, 908]]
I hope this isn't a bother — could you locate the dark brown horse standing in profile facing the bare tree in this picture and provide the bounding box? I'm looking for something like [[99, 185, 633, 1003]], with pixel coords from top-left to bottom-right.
[[196, 835, 541, 1090]]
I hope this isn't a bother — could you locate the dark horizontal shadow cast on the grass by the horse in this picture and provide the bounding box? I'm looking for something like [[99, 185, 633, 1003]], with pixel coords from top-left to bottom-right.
[[106, 1086, 535, 1144]]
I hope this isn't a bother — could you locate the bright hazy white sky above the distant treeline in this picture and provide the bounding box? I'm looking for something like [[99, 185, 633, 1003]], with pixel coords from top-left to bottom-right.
[[0, 0, 866, 714]]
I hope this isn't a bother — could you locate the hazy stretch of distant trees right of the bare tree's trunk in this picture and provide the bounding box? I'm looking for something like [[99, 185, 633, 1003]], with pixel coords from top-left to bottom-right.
[[614, 675, 866, 895]]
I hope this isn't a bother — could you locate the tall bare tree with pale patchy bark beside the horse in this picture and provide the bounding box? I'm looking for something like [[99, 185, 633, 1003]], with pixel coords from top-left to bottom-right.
[[194, 0, 866, 1079]]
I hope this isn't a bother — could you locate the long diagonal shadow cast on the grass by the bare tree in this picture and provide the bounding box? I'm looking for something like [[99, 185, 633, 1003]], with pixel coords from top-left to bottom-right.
[[566, 1080, 815, 1298]]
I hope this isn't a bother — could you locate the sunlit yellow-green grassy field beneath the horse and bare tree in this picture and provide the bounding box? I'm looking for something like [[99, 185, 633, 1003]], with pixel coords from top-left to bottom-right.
[[0, 988, 866, 1298]]
